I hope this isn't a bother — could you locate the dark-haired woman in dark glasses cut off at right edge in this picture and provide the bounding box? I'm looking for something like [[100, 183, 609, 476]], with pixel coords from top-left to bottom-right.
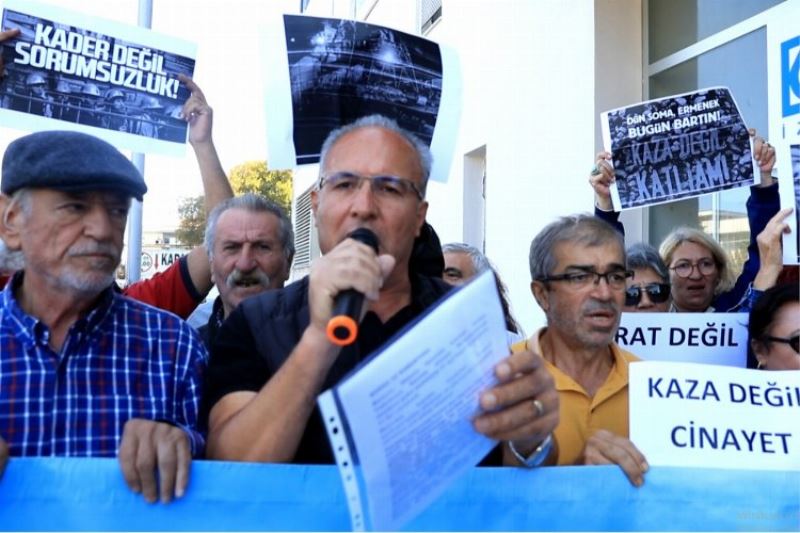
[[748, 284, 800, 370]]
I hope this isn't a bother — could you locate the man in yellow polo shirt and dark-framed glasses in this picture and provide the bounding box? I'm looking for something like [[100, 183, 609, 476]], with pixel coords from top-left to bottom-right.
[[512, 215, 648, 487]]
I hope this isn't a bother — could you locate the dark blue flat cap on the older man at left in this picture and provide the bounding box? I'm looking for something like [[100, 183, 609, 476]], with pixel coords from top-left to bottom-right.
[[0, 131, 147, 200]]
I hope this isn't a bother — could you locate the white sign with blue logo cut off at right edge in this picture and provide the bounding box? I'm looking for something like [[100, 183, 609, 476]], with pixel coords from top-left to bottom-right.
[[767, 2, 800, 265]]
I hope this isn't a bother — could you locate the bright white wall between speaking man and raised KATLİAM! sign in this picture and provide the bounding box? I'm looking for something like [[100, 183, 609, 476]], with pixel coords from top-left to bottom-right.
[[412, 0, 594, 333]]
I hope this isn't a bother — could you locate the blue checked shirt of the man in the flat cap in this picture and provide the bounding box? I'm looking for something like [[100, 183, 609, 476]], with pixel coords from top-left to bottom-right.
[[0, 272, 208, 457]]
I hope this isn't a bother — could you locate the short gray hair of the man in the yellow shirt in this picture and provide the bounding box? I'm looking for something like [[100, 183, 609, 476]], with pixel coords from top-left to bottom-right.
[[528, 213, 625, 280]]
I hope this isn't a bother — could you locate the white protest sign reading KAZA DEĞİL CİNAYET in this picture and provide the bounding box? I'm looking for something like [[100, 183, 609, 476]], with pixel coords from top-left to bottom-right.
[[629, 361, 800, 470]]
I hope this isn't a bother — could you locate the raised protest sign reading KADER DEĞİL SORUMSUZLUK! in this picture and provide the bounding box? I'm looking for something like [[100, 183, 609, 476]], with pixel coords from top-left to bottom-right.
[[0, 0, 195, 155]]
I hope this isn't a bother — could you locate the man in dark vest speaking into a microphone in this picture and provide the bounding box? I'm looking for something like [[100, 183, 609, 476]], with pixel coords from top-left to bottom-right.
[[204, 116, 558, 464]]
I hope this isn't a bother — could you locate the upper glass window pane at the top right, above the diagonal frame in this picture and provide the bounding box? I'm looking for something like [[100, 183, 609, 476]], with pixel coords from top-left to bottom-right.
[[647, 0, 784, 63]]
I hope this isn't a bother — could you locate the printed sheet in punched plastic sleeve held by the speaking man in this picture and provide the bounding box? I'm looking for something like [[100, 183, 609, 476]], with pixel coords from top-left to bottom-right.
[[320, 272, 509, 530]]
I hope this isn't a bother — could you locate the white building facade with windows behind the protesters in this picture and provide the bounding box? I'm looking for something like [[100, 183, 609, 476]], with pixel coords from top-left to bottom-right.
[[294, 0, 800, 333]]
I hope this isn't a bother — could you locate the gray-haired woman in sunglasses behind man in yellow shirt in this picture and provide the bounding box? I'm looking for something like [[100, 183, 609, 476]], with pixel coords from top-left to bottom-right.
[[623, 243, 671, 313]]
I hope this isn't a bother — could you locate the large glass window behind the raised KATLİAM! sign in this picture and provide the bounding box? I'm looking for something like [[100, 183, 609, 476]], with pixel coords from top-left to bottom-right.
[[650, 27, 767, 276]]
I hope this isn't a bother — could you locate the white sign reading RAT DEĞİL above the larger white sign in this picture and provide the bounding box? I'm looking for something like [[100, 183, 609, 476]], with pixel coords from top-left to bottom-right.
[[616, 313, 747, 368]]
